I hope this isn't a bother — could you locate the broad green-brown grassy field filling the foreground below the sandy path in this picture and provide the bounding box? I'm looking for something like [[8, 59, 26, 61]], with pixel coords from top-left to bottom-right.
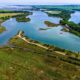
[[0, 37, 80, 80]]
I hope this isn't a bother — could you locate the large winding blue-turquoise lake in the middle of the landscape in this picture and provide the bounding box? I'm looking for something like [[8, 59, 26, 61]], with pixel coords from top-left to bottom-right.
[[0, 11, 80, 52]]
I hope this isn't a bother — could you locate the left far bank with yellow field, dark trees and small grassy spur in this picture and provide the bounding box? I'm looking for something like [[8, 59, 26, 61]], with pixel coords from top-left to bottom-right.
[[0, 11, 31, 33]]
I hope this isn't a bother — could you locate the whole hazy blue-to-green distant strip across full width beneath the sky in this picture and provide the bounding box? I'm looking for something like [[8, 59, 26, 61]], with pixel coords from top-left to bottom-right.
[[0, 4, 80, 10]]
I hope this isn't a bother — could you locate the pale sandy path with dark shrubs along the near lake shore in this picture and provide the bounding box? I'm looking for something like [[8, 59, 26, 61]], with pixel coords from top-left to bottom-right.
[[17, 31, 80, 55]]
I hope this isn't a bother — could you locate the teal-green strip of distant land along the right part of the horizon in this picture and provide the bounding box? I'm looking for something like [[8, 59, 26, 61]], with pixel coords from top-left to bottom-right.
[[35, 5, 80, 11]]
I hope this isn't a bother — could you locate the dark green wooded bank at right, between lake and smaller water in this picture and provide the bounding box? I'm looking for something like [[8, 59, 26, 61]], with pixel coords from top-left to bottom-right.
[[47, 10, 80, 36]]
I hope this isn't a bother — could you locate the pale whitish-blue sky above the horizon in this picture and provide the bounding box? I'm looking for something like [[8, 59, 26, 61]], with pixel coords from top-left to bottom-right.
[[0, 0, 80, 5]]
